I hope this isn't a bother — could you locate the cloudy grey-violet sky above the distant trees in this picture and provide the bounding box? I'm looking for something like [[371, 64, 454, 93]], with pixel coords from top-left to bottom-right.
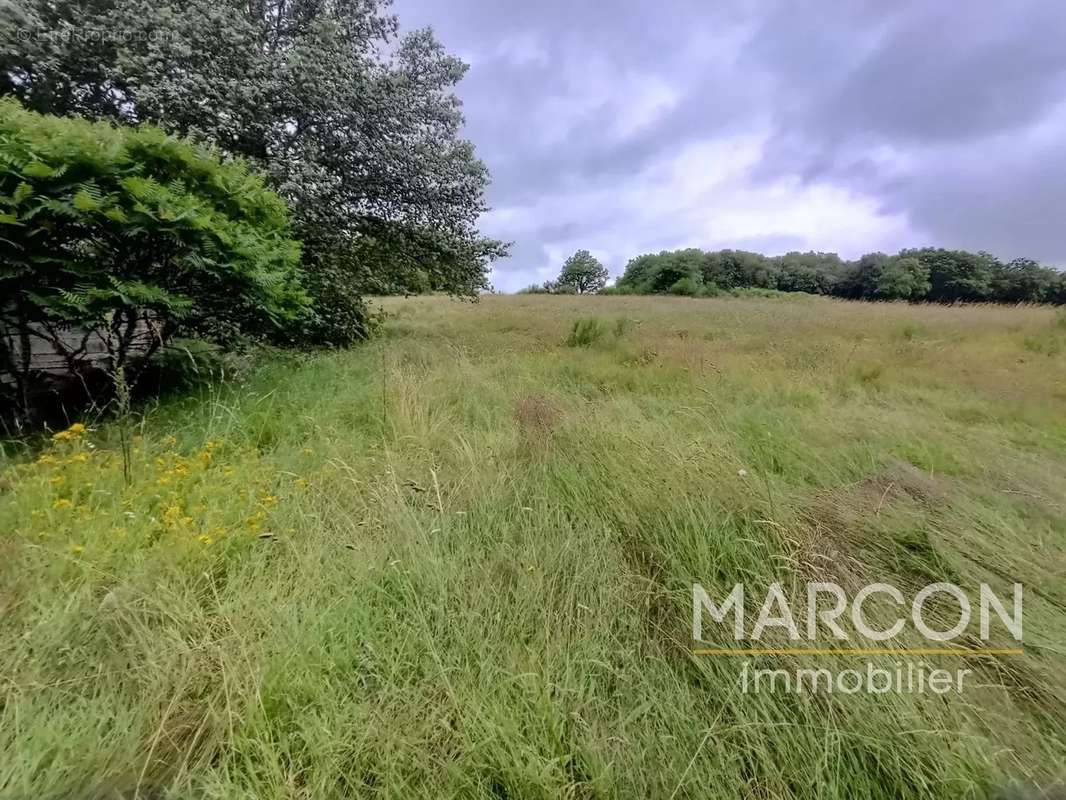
[[394, 0, 1066, 291]]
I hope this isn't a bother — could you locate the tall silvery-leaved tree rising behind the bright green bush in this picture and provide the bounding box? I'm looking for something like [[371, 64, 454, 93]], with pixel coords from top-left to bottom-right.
[[0, 0, 505, 342]]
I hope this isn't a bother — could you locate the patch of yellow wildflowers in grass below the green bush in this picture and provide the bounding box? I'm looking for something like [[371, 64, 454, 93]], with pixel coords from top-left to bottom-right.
[[0, 423, 309, 559]]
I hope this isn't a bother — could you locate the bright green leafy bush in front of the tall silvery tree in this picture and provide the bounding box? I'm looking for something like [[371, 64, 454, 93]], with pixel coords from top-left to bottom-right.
[[0, 100, 309, 420]]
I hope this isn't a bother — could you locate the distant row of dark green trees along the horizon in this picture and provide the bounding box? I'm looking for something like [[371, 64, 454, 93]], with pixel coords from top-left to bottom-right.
[[533, 247, 1066, 305]]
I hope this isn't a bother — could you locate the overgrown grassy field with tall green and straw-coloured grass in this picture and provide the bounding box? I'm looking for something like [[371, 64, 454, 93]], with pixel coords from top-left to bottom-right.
[[0, 295, 1066, 800]]
